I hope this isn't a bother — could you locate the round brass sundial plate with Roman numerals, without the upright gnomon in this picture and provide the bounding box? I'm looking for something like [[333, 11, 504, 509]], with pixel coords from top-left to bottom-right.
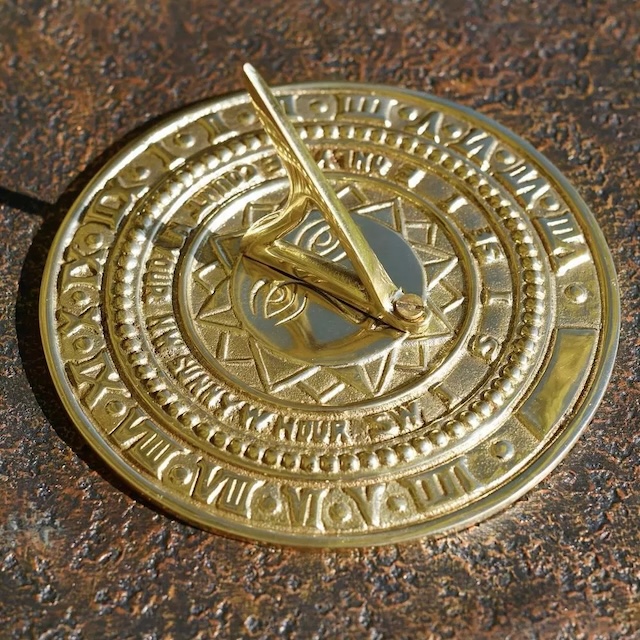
[[41, 83, 619, 547]]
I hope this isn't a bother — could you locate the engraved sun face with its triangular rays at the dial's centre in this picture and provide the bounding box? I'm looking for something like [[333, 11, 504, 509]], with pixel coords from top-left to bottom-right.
[[185, 179, 467, 407]]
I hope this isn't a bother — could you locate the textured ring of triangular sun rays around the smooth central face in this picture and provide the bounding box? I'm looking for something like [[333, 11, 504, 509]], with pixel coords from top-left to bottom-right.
[[192, 185, 464, 405]]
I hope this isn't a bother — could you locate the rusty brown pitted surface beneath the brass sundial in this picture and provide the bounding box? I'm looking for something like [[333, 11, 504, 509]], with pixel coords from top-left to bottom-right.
[[0, 0, 640, 640]]
